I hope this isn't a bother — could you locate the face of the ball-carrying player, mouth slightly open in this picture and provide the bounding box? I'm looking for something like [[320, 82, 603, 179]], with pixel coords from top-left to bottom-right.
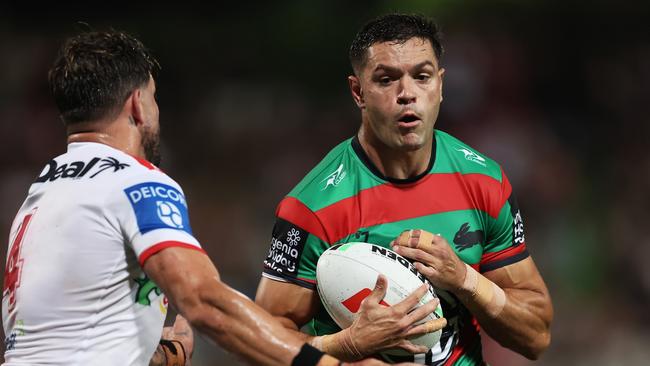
[[350, 38, 444, 151]]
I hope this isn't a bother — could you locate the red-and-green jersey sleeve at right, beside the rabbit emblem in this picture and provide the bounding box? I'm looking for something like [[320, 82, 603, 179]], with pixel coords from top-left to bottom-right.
[[479, 172, 529, 272]]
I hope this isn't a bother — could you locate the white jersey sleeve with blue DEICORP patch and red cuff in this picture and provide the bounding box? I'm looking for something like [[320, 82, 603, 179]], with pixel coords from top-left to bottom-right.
[[107, 170, 203, 266]]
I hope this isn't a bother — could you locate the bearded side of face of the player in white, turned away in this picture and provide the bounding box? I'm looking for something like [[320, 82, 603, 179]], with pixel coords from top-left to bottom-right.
[[142, 78, 161, 165]]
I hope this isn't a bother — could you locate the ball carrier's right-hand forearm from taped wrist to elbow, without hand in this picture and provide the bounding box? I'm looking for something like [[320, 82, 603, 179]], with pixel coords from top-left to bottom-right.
[[456, 269, 551, 359]]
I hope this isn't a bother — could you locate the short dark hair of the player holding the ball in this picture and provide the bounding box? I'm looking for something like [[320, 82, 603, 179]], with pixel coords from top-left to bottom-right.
[[350, 14, 443, 73]]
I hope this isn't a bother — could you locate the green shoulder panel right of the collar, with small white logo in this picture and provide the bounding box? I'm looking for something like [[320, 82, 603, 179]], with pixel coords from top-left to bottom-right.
[[435, 130, 505, 183]]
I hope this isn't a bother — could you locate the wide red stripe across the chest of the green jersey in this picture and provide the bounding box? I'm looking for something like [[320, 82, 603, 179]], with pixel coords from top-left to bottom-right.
[[314, 173, 502, 244]]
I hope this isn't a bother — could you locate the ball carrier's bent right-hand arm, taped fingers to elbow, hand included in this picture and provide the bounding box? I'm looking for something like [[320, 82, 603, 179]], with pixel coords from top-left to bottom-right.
[[393, 230, 553, 359]]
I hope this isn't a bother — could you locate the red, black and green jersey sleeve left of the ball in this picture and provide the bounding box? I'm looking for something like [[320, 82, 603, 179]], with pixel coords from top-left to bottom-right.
[[262, 197, 329, 290]]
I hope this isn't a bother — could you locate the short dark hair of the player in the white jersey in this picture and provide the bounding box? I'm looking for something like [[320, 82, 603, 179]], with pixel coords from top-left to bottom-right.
[[48, 30, 160, 125]]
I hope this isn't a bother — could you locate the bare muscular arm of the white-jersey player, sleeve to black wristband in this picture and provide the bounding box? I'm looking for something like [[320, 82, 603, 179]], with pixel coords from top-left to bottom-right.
[[144, 247, 332, 365]]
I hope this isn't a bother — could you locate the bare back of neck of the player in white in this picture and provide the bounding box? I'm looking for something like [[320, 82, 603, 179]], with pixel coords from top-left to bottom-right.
[[67, 120, 145, 159]]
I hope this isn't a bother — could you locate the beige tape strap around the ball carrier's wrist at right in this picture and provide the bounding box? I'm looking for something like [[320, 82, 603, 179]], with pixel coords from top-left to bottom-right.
[[462, 264, 507, 318]]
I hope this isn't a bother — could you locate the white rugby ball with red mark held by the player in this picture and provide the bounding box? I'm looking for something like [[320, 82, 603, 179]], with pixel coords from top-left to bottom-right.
[[316, 242, 442, 355]]
